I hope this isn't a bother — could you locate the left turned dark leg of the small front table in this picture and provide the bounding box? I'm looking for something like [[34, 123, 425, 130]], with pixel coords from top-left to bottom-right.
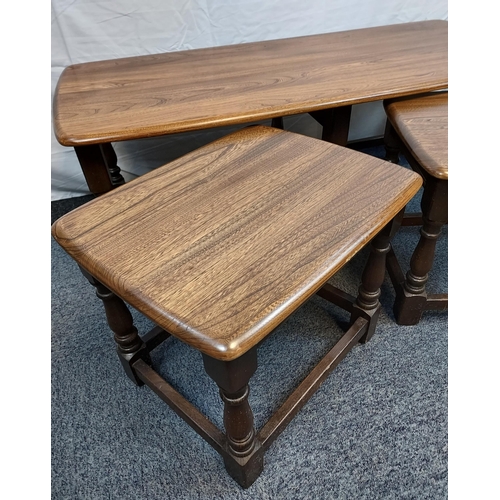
[[80, 268, 151, 385]]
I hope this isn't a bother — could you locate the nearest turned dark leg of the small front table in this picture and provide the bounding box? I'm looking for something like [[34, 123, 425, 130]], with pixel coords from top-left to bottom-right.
[[203, 348, 264, 488]]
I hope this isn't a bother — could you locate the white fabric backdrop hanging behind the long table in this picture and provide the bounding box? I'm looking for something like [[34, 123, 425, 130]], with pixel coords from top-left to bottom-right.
[[51, 0, 448, 200]]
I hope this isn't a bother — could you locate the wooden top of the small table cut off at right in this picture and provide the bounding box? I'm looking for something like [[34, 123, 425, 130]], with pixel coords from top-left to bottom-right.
[[384, 92, 448, 180]]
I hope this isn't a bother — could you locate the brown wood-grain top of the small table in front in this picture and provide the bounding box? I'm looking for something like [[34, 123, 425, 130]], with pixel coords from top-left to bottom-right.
[[52, 126, 422, 360]]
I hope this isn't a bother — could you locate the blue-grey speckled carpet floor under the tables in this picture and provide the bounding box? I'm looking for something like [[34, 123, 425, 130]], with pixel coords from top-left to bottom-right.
[[51, 144, 448, 500]]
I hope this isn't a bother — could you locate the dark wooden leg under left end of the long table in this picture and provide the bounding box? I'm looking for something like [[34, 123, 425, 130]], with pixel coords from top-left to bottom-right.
[[75, 144, 125, 194]]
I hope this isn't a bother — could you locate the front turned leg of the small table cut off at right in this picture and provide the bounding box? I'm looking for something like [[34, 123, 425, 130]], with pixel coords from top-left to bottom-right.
[[394, 178, 448, 325]]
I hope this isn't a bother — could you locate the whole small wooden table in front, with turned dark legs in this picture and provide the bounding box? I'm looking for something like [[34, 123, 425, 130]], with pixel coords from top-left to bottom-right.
[[52, 126, 422, 488]]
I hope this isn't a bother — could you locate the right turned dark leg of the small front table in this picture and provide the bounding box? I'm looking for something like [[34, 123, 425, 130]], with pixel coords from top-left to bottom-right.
[[350, 211, 404, 343]]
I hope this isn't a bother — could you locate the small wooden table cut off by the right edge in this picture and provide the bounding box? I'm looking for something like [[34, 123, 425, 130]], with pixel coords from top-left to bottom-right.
[[384, 92, 448, 325]]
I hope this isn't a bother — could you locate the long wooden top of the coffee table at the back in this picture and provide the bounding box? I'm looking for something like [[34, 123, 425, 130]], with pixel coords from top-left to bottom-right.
[[53, 20, 448, 146]]
